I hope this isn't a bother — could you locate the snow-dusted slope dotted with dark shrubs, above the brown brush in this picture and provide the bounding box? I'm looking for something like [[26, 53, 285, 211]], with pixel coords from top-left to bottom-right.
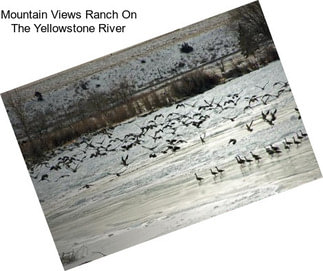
[[3, 12, 239, 139]]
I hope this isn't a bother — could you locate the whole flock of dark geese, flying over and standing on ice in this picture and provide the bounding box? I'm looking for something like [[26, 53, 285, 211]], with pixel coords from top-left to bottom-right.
[[30, 76, 307, 189]]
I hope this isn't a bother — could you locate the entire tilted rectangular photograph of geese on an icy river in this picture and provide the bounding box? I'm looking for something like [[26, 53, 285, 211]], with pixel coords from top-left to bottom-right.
[[1, 1, 322, 270]]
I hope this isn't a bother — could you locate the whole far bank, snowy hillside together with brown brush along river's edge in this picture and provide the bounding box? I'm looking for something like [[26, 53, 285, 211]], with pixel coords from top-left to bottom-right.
[[1, 2, 278, 164]]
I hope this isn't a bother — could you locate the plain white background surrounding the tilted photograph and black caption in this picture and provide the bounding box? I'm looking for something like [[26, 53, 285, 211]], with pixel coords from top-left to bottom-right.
[[0, 0, 323, 271]]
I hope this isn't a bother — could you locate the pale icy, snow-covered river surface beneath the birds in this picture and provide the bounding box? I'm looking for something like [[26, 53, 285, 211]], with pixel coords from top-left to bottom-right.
[[30, 61, 321, 268]]
